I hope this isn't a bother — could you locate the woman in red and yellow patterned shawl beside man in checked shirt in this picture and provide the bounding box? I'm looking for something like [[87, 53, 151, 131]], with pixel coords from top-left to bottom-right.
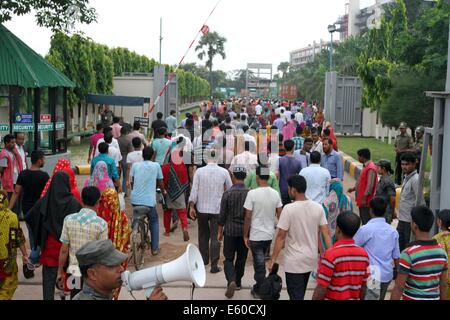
[[94, 189, 131, 300]]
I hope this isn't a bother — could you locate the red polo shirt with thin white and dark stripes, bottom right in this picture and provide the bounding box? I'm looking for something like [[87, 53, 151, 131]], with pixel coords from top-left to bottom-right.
[[317, 240, 370, 300]]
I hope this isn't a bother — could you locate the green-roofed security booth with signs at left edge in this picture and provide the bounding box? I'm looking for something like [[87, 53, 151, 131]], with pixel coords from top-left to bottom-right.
[[0, 25, 75, 169]]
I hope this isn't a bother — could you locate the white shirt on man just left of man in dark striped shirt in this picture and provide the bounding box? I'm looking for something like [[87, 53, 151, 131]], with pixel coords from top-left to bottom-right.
[[189, 164, 233, 214]]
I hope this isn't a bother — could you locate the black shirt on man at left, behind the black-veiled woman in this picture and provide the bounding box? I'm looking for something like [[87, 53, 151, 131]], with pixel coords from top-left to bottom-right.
[[17, 169, 50, 214]]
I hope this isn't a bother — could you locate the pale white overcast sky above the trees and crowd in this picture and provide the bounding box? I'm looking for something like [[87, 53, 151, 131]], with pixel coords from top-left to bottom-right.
[[5, 0, 375, 72]]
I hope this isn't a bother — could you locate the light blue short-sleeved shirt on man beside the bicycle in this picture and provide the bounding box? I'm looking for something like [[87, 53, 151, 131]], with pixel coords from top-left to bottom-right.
[[130, 161, 163, 207]]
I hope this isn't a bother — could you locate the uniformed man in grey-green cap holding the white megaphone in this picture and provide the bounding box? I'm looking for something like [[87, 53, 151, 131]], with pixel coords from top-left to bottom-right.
[[73, 240, 167, 301]]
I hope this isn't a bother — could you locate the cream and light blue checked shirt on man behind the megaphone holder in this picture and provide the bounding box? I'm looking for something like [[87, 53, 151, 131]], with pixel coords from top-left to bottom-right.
[[59, 208, 108, 266]]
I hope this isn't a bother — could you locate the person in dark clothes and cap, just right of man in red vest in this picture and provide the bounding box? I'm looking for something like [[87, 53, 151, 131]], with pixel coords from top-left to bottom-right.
[[375, 159, 397, 223]]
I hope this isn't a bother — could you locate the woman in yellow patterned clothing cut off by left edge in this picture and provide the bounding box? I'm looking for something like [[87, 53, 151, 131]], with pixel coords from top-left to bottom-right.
[[0, 190, 28, 300]]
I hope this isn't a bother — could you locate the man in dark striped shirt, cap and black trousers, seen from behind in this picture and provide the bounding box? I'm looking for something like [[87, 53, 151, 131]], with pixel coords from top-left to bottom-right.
[[218, 166, 250, 299]]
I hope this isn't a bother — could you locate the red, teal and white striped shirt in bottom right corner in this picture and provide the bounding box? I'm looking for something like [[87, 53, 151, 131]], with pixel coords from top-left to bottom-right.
[[399, 240, 448, 300]]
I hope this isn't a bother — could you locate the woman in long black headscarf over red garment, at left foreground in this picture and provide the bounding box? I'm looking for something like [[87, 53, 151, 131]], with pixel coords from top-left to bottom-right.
[[26, 170, 82, 300]]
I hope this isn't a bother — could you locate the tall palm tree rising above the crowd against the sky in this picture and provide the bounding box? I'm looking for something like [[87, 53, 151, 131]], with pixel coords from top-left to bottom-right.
[[195, 32, 227, 96]]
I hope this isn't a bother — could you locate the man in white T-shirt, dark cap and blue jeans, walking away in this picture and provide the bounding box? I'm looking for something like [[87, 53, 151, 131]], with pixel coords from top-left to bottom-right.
[[244, 167, 283, 299]]
